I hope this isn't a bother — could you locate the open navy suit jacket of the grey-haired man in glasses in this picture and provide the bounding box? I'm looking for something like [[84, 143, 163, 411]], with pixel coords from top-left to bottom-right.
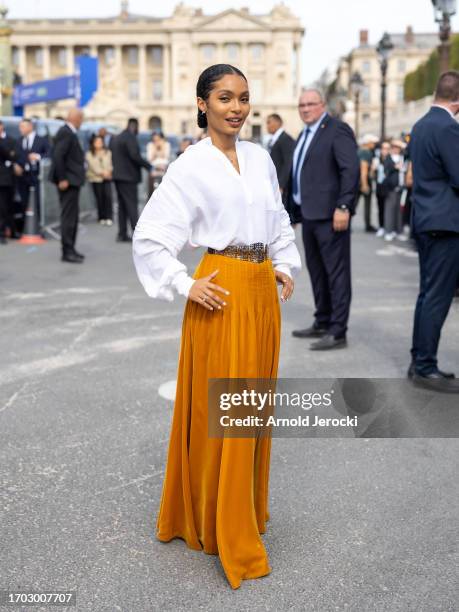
[[287, 115, 360, 223]]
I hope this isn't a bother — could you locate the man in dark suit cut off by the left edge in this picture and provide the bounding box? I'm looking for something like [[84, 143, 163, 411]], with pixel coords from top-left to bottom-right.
[[0, 121, 18, 244]]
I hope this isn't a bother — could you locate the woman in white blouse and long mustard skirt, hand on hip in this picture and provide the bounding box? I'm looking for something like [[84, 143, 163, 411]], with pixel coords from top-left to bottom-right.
[[133, 64, 301, 589]]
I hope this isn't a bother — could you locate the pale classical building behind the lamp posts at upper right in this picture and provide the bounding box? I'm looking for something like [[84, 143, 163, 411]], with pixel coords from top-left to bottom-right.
[[335, 26, 439, 133]]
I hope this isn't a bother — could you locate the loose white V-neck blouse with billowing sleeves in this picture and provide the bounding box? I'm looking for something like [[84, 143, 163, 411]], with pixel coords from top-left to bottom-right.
[[132, 137, 301, 301]]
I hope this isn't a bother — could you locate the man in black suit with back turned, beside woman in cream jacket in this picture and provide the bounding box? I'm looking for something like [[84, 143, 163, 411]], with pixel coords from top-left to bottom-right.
[[110, 118, 151, 242]]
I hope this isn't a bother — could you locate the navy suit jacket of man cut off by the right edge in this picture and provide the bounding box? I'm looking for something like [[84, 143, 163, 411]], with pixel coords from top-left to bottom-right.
[[409, 106, 459, 233]]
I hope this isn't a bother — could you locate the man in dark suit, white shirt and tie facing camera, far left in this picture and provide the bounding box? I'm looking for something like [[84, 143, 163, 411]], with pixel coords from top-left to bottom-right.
[[16, 119, 51, 233]]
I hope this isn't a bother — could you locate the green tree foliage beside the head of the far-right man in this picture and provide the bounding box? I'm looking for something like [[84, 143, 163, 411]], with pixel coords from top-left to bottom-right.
[[404, 34, 459, 102]]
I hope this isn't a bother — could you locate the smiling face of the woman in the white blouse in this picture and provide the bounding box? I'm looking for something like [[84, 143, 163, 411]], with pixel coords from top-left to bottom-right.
[[198, 74, 250, 136]]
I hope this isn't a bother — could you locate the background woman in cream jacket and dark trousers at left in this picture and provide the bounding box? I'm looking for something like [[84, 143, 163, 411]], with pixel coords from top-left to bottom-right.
[[86, 136, 113, 225]]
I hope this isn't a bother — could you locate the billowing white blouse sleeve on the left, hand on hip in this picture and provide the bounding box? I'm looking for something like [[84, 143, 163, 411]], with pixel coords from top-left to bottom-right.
[[132, 156, 198, 302]]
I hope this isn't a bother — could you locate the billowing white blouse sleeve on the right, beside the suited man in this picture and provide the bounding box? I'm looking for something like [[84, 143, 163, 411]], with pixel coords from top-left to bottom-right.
[[267, 154, 301, 278]]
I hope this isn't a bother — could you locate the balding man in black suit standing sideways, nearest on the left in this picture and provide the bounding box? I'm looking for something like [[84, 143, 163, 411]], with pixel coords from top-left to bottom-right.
[[49, 108, 85, 263]]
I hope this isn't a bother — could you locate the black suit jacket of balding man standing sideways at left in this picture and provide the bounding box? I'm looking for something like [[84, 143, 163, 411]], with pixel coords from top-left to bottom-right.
[[49, 125, 85, 187]]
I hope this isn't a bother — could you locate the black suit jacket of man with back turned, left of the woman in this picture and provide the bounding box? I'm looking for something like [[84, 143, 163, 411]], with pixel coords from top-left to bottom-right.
[[110, 130, 151, 183]]
